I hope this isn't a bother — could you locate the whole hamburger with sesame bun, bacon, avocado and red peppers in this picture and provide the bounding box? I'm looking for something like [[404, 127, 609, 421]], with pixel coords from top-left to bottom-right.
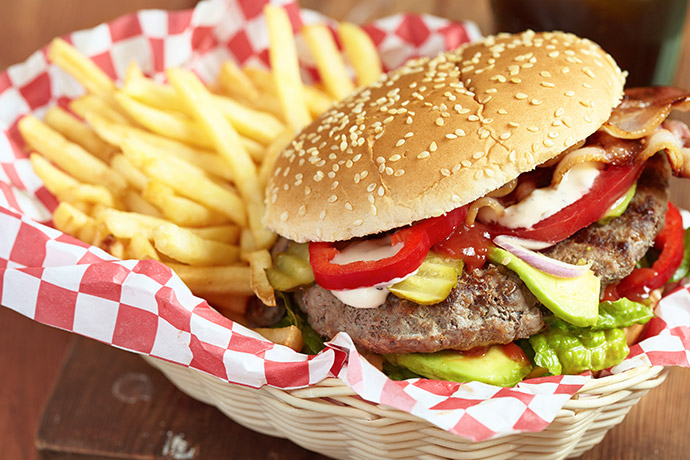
[[265, 32, 690, 384]]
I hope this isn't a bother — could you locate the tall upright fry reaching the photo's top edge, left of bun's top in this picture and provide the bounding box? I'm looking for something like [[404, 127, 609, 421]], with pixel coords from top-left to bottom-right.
[[264, 4, 311, 130]]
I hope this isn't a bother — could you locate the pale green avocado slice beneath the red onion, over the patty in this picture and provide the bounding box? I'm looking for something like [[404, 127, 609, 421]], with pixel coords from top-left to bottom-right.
[[489, 247, 600, 327]]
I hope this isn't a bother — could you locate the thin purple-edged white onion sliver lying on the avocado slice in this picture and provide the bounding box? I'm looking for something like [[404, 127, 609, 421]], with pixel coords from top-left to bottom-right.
[[494, 235, 592, 278]]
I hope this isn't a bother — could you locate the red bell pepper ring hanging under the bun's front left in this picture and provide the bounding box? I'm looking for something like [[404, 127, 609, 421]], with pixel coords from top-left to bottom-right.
[[309, 206, 467, 290]]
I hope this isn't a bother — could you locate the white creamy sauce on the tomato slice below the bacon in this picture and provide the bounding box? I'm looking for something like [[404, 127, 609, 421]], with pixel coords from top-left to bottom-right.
[[480, 162, 600, 228]]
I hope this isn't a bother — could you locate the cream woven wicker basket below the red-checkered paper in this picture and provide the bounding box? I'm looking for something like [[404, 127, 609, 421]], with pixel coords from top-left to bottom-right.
[[144, 357, 667, 460]]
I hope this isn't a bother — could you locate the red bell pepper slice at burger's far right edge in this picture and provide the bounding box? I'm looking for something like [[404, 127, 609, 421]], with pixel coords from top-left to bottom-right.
[[606, 203, 685, 300]]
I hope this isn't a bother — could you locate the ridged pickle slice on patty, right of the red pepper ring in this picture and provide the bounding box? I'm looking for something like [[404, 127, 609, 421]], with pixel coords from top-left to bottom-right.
[[388, 252, 463, 305]]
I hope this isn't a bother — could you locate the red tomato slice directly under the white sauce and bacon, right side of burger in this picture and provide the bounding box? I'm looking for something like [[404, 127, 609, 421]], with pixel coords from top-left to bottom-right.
[[490, 163, 644, 243]]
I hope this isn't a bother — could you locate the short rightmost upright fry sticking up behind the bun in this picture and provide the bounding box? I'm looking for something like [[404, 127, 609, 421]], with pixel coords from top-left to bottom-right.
[[338, 22, 383, 86]]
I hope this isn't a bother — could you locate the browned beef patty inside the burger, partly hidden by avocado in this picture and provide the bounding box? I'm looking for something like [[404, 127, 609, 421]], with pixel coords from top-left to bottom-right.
[[295, 155, 670, 354]]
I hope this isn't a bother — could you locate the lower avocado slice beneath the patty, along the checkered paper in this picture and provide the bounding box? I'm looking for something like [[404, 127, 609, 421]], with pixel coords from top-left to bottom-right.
[[385, 343, 532, 387]]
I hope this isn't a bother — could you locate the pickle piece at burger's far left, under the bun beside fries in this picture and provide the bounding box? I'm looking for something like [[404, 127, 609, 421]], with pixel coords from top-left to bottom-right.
[[266, 243, 314, 292]]
